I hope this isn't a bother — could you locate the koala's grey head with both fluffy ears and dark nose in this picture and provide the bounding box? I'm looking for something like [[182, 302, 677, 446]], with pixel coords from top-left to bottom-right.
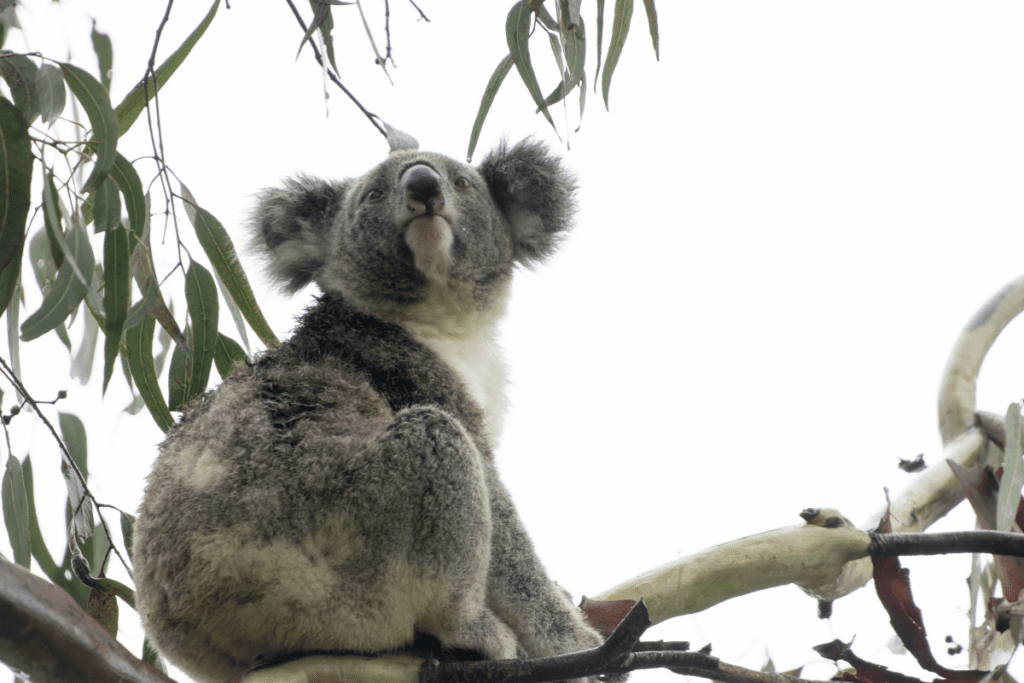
[[254, 140, 575, 325]]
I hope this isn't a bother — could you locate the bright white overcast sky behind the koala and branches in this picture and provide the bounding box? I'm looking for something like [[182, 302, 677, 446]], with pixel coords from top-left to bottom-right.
[[0, 0, 1024, 683]]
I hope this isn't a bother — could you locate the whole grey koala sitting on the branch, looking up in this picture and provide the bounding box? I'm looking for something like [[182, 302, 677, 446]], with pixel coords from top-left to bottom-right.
[[132, 140, 614, 682]]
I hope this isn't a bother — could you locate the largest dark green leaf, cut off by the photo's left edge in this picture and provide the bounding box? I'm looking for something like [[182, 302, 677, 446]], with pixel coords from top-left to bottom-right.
[[0, 97, 32, 312]]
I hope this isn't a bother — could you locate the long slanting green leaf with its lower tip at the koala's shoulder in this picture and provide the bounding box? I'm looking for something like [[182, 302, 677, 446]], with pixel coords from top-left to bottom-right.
[[181, 185, 281, 348]]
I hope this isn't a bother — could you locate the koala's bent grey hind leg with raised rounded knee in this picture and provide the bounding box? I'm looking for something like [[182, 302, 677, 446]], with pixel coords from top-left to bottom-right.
[[369, 407, 517, 659]]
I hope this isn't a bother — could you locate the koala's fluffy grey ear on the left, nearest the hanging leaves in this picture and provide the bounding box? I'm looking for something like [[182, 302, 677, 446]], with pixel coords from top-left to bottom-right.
[[252, 176, 345, 294]]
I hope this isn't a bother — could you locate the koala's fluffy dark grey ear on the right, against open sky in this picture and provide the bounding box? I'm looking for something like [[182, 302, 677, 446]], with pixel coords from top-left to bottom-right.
[[476, 139, 577, 265]]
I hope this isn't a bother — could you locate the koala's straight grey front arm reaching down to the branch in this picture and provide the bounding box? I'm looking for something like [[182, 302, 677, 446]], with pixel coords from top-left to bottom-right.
[[487, 468, 604, 657]]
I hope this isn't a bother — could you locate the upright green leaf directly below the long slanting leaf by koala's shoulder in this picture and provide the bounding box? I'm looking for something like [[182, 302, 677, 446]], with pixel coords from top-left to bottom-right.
[[182, 261, 219, 403]]
